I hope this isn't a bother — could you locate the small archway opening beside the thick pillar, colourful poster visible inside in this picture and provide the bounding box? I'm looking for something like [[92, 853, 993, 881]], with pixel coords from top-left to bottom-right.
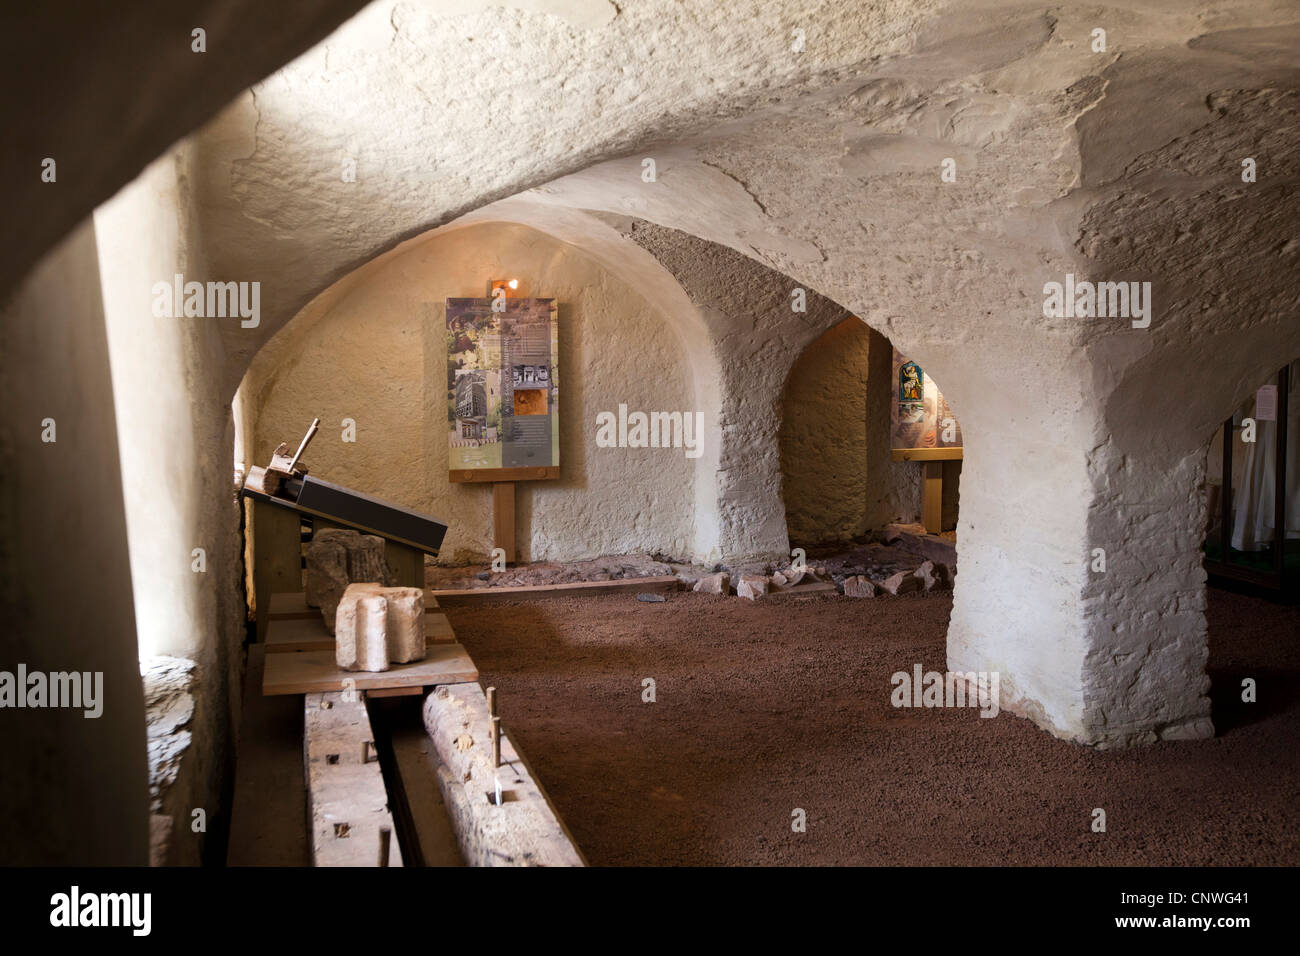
[[780, 316, 961, 584]]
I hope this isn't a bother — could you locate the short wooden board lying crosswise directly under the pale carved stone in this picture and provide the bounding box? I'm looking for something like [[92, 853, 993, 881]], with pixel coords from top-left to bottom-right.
[[261, 644, 478, 696]]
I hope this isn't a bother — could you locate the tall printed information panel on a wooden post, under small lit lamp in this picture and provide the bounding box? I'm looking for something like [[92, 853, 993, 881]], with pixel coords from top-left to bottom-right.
[[447, 298, 560, 481]]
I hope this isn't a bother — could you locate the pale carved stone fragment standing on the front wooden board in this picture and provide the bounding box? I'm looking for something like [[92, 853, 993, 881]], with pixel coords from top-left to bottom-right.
[[334, 584, 425, 671]]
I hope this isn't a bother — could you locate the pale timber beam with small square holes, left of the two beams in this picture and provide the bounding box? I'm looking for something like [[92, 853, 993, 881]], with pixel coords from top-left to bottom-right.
[[305, 697, 402, 866]]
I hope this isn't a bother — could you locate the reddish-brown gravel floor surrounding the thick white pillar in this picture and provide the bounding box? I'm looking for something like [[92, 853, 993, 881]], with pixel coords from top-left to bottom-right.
[[447, 591, 1300, 865]]
